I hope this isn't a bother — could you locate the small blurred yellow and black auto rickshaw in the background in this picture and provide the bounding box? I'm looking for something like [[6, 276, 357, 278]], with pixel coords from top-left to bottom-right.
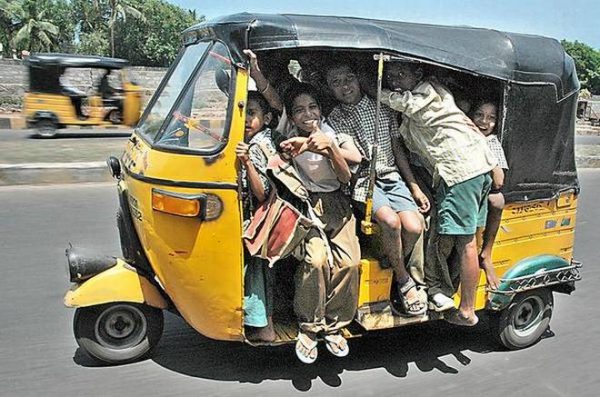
[[23, 53, 142, 137]]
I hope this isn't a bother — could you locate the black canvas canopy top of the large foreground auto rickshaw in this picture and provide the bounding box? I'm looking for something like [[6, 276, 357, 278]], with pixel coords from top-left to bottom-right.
[[184, 13, 579, 100]]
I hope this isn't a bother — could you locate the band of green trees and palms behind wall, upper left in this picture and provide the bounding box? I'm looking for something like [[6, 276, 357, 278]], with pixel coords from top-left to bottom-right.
[[0, 0, 204, 66]]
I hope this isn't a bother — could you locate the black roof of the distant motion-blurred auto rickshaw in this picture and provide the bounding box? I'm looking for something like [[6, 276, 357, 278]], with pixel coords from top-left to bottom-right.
[[27, 53, 129, 69]]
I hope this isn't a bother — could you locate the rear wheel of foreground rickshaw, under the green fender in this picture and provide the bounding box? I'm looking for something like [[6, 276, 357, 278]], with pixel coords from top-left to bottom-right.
[[490, 288, 554, 350]]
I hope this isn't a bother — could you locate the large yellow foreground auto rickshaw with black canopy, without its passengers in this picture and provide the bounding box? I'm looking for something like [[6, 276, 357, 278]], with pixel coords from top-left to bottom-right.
[[65, 14, 580, 363]]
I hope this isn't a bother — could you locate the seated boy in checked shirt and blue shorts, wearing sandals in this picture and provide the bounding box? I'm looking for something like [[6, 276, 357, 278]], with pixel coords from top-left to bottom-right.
[[326, 60, 429, 316]]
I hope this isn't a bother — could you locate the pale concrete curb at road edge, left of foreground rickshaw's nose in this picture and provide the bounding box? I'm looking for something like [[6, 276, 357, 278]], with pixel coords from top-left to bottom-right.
[[0, 161, 112, 186]]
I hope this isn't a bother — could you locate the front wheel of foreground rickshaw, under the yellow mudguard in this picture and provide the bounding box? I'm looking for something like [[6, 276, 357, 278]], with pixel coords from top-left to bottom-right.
[[73, 302, 164, 364]]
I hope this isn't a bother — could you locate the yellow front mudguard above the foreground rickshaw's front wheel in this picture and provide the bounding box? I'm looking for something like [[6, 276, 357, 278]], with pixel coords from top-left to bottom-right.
[[64, 259, 167, 309]]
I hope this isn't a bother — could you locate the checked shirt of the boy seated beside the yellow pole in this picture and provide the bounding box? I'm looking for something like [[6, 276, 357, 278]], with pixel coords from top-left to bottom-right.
[[328, 95, 400, 202]]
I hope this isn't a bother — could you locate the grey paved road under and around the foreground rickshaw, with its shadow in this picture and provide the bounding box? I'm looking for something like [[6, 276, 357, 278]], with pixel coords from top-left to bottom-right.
[[0, 170, 600, 397]]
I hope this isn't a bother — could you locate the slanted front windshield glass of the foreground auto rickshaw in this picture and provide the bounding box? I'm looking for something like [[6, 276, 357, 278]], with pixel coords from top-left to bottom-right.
[[138, 42, 210, 142]]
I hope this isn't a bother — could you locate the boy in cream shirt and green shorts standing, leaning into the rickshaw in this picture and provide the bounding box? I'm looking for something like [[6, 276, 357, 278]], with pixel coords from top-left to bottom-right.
[[382, 63, 497, 326]]
